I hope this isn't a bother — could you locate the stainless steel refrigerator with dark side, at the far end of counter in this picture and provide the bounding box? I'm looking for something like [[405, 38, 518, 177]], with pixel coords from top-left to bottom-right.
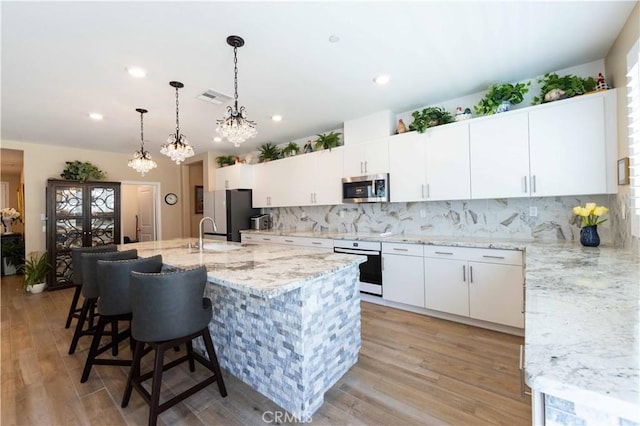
[[203, 189, 260, 242]]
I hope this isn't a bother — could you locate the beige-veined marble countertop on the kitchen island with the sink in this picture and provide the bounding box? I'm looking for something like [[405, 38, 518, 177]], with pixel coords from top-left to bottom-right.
[[120, 238, 366, 298]]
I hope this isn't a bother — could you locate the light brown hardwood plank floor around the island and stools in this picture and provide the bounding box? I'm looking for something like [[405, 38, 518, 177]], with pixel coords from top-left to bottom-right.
[[0, 276, 531, 426]]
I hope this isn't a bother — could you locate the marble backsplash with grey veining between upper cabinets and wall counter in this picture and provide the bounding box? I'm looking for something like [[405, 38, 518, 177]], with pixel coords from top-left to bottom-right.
[[266, 194, 637, 247]]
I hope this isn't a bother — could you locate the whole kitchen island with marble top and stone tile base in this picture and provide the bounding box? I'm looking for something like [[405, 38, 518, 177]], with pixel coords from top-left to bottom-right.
[[126, 239, 365, 421]]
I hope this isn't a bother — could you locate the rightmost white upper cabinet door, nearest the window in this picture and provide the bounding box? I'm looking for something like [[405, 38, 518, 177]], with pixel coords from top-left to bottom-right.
[[529, 95, 615, 197]]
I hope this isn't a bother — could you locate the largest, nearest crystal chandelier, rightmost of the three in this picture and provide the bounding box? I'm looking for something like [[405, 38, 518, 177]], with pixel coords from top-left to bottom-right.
[[216, 36, 258, 146]]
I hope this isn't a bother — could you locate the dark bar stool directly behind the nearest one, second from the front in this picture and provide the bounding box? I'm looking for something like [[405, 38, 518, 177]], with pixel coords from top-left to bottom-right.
[[80, 255, 162, 383]]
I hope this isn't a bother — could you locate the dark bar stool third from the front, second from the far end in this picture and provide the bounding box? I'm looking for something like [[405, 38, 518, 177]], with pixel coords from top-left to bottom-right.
[[69, 250, 138, 355]]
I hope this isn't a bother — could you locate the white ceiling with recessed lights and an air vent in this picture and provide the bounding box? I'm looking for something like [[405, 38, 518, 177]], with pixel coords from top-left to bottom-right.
[[0, 0, 637, 156]]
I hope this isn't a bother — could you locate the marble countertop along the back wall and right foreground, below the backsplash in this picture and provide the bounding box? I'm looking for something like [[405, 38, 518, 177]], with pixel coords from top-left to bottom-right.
[[243, 230, 640, 416]]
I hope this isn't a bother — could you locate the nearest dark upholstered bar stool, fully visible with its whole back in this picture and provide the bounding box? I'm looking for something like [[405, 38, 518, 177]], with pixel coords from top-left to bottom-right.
[[122, 266, 227, 426]]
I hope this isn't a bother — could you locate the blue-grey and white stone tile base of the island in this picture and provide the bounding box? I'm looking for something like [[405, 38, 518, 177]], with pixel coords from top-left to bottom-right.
[[198, 264, 361, 421]]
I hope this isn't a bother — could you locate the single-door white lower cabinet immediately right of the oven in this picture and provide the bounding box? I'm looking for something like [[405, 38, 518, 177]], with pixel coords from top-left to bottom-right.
[[382, 243, 424, 308]]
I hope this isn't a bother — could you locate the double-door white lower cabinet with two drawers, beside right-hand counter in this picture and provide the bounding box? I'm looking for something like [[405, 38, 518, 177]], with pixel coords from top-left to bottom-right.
[[424, 246, 524, 328]]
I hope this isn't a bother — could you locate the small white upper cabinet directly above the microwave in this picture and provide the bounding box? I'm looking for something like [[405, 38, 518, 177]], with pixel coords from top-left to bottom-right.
[[343, 137, 389, 177]]
